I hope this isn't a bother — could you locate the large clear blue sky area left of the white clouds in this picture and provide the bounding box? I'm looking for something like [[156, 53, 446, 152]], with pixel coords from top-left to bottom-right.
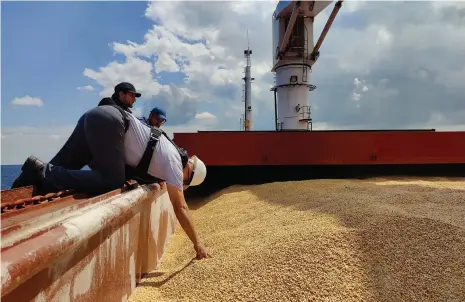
[[1, 2, 153, 126]]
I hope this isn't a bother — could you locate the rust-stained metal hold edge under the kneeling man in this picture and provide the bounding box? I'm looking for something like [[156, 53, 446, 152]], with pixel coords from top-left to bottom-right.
[[2, 184, 177, 301]]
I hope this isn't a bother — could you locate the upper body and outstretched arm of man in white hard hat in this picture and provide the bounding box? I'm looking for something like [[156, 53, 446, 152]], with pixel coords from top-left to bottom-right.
[[124, 113, 211, 259]]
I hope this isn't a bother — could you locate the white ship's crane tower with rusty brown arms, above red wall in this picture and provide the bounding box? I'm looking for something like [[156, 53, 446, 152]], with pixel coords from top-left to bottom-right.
[[271, 1, 342, 130]]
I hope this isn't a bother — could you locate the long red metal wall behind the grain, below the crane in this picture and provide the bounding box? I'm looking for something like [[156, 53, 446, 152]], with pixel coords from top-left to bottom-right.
[[174, 131, 465, 166]]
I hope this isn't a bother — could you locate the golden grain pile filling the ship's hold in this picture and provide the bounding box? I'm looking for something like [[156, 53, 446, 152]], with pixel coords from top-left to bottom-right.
[[129, 178, 465, 302]]
